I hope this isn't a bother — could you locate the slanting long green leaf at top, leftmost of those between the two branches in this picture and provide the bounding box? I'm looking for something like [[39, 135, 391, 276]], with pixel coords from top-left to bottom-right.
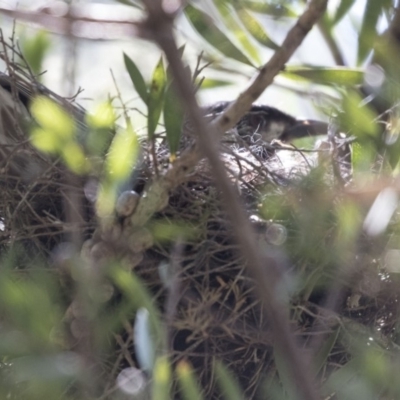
[[185, 4, 253, 66]]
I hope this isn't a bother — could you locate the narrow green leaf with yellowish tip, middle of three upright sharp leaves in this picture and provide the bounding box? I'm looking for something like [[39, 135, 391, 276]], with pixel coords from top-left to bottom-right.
[[147, 58, 166, 140]]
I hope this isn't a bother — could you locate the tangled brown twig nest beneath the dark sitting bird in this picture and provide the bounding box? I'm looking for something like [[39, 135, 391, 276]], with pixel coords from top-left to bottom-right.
[[0, 54, 398, 399]]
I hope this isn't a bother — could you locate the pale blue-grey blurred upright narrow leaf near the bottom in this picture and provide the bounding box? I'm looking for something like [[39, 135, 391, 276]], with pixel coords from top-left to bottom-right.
[[133, 308, 157, 373]]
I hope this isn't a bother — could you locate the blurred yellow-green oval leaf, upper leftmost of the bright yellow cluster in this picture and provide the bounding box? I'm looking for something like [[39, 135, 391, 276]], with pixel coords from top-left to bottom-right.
[[31, 96, 75, 141]]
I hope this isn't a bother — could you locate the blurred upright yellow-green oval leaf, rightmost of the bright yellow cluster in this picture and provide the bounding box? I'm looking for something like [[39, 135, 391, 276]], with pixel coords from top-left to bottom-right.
[[106, 126, 139, 182]]
